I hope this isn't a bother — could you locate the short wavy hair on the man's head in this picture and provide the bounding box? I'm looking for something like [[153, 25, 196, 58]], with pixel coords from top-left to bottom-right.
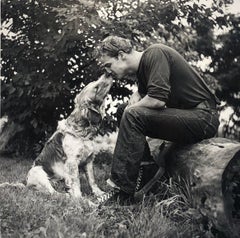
[[99, 36, 133, 57]]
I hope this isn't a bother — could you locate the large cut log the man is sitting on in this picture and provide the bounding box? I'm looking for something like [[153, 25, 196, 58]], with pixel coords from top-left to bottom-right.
[[150, 138, 240, 237]]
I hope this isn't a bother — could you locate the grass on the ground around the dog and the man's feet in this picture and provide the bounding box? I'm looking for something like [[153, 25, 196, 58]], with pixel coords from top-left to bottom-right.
[[0, 155, 206, 238]]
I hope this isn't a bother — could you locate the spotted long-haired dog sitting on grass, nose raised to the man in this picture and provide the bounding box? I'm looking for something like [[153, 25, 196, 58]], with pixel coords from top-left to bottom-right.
[[26, 74, 113, 198]]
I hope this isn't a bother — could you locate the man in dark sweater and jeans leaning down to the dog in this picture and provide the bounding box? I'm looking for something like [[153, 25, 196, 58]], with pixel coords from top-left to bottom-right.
[[97, 36, 219, 205]]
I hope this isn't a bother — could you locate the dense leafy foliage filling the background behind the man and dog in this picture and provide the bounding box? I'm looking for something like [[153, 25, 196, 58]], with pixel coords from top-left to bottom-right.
[[1, 0, 239, 154]]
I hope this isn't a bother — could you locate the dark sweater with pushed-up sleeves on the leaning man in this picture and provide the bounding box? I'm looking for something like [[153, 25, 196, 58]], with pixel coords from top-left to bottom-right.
[[137, 44, 218, 109]]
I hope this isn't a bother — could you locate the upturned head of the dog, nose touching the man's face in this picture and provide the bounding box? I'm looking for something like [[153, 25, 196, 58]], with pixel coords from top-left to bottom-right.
[[70, 74, 113, 125]]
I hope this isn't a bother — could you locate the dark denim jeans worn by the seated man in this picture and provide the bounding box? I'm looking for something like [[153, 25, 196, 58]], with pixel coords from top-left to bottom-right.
[[110, 104, 219, 194]]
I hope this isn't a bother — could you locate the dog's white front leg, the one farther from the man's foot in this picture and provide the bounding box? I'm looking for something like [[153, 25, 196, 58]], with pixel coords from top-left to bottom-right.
[[65, 159, 82, 198]]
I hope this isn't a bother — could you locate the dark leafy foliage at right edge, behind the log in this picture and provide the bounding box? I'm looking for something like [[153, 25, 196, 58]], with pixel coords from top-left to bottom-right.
[[212, 15, 240, 139]]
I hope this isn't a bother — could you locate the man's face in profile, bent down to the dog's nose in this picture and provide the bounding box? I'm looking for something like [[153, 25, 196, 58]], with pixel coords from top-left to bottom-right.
[[100, 53, 131, 79]]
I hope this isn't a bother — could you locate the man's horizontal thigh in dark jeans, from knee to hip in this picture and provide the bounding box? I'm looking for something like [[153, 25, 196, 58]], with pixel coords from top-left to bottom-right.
[[136, 108, 216, 144]]
